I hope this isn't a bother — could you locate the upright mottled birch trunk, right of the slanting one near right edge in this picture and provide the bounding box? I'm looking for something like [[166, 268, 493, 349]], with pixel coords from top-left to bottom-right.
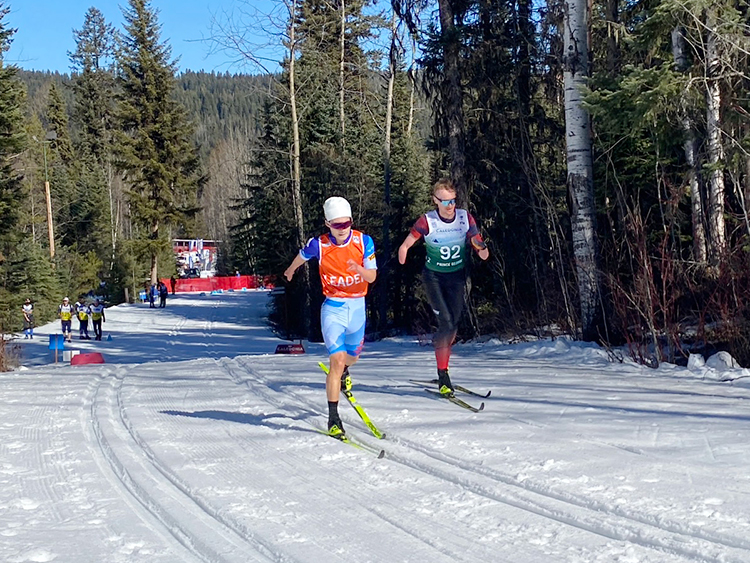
[[706, 8, 726, 266]]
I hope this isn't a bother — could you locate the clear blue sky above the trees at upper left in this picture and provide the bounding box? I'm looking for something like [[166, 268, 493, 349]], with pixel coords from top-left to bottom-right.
[[4, 0, 270, 72]]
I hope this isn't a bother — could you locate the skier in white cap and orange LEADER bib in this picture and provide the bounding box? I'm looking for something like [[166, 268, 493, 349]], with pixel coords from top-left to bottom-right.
[[284, 197, 377, 436]]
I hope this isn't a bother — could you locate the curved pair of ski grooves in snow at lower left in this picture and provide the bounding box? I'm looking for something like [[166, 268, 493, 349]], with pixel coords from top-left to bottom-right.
[[82, 368, 294, 563]]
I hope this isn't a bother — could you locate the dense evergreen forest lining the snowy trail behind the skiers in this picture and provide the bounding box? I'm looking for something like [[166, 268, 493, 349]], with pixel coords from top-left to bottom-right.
[[0, 0, 750, 366]]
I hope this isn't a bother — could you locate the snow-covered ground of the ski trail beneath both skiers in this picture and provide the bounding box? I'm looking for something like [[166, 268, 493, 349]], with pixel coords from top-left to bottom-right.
[[0, 292, 750, 563]]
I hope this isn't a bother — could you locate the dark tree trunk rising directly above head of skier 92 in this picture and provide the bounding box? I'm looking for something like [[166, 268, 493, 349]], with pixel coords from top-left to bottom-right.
[[438, 0, 469, 199]]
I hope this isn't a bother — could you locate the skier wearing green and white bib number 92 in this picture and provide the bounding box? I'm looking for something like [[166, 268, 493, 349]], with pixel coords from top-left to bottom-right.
[[398, 180, 490, 396]]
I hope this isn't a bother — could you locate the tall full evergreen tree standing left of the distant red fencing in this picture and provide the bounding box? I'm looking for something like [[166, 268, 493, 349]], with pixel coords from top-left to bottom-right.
[[116, 0, 202, 283]]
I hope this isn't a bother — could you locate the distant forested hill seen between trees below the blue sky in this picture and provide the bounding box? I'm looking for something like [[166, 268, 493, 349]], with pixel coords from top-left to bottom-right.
[[19, 70, 270, 159]]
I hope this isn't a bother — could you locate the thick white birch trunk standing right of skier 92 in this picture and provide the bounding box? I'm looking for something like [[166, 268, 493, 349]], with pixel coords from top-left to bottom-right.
[[563, 0, 601, 341]]
